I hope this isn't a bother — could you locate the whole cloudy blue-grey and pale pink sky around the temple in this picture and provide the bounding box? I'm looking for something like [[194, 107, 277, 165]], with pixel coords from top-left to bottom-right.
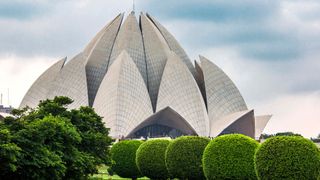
[[0, 0, 320, 137]]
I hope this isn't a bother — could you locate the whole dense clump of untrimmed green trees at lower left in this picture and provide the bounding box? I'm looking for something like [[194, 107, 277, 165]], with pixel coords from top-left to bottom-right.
[[0, 97, 111, 179]]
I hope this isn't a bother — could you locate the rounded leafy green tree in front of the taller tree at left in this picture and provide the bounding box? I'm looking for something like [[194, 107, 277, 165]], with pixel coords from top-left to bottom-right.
[[13, 116, 81, 179]]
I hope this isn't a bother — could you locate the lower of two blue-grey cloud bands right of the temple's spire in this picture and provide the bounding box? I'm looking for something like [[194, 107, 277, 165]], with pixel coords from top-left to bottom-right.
[[164, 23, 307, 61]]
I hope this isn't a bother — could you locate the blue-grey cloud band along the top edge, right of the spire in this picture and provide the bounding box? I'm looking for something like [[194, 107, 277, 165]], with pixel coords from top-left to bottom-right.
[[142, 0, 279, 23]]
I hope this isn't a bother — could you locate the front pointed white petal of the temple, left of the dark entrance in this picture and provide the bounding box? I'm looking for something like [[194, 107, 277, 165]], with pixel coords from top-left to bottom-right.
[[93, 51, 153, 137]]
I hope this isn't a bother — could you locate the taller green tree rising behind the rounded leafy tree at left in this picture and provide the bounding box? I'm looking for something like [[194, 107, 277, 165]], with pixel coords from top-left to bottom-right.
[[32, 97, 112, 178]]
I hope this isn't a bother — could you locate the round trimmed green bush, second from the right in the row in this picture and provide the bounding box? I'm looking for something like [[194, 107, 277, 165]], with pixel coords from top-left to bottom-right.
[[203, 134, 259, 179]]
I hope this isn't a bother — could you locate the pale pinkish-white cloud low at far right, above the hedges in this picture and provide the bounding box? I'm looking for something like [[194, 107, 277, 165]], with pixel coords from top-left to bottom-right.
[[258, 91, 320, 138]]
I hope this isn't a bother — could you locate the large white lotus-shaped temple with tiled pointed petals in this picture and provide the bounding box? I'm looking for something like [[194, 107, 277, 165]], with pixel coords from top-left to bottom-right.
[[20, 12, 271, 138]]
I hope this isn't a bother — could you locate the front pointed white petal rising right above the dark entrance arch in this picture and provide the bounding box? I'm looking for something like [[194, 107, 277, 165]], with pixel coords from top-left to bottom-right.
[[157, 52, 209, 136]]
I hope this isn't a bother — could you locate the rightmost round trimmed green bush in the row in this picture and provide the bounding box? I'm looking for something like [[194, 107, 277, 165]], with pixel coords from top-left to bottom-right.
[[254, 136, 320, 180]]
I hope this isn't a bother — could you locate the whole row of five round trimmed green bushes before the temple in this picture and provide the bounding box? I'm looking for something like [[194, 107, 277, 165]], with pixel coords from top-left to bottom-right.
[[111, 134, 320, 180]]
